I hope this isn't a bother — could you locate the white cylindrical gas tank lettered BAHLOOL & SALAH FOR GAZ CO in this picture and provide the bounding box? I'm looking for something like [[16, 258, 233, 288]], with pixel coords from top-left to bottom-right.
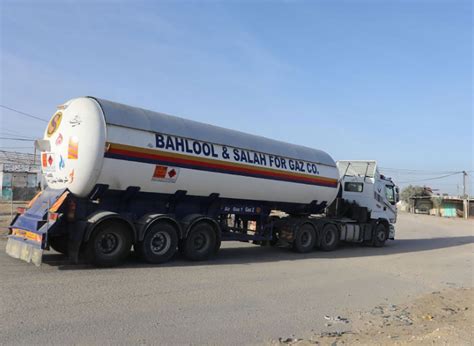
[[41, 97, 339, 204]]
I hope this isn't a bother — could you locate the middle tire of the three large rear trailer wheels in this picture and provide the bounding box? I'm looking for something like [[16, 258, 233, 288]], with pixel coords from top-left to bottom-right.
[[137, 222, 178, 264]]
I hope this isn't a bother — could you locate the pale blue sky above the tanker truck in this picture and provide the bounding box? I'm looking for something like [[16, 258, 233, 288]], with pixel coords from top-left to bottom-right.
[[0, 0, 474, 194]]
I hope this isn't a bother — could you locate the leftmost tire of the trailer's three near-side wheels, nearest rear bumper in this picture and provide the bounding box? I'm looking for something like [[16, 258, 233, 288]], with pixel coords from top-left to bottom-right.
[[86, 221, 132, 267]]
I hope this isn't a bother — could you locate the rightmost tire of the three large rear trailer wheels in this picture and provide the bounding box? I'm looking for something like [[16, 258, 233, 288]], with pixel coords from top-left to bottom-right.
[[184, 222, 217, 261]]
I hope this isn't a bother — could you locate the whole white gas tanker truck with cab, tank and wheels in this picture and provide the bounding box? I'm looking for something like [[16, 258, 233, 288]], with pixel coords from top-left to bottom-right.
[[6, 97, 398, 266]]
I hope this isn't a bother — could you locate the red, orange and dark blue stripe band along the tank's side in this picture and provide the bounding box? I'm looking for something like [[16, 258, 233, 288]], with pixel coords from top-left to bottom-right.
[[105, 143, 337, 188]]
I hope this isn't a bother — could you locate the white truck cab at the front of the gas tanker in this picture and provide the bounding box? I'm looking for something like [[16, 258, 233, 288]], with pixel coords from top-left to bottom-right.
[[337, 161, 399, 239]]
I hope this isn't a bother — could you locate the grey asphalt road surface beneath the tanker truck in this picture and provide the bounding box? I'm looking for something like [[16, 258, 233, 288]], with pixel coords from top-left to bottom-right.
[[0, 214, 474, 345]]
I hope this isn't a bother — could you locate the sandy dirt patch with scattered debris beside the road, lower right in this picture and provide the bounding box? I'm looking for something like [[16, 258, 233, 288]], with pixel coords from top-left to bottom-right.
[[274, 288, 474, 346]]
